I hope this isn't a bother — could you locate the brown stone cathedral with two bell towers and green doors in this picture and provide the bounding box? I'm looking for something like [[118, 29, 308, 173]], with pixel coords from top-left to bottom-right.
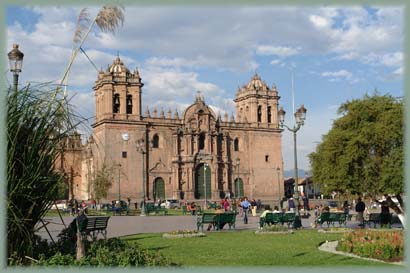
[[60, 57, 284, 201]]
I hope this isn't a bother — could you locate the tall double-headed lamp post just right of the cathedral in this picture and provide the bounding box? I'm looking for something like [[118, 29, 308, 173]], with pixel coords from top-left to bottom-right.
[[278, 104, 306, 228]]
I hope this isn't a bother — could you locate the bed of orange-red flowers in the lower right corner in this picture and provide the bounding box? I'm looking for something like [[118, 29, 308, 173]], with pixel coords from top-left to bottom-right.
[[337, 230, 404, 262]]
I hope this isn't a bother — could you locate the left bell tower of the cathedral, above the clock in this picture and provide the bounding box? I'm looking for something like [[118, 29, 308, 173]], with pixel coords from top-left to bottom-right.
[[94, 56, 144, 123]]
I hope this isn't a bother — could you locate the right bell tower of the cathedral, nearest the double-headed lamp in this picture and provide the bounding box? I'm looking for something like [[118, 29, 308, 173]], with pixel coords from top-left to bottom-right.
[[234, 74, 280, 128]]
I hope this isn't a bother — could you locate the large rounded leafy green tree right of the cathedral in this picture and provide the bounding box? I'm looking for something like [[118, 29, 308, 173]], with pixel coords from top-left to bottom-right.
[[309, 93, 404, 217]]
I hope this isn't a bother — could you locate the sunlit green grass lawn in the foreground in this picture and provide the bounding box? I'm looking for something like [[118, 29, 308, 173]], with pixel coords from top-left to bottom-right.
[[122, 230, 393, 267]]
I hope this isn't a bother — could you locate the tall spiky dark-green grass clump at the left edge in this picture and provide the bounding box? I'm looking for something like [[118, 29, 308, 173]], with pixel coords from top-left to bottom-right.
[[7, 85, 73, 263]]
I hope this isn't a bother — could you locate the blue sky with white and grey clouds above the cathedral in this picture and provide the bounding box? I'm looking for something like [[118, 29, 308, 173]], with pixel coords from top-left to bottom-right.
[[6, 5, 404, 170]]
